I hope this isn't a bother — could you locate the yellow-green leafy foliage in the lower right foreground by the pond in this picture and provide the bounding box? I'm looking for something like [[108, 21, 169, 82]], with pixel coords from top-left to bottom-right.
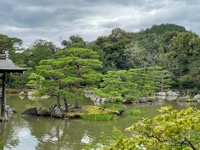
[[93, 107, 200, 150]]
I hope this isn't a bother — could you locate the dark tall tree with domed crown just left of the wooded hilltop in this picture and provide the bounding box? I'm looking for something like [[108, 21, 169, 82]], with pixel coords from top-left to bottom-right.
[[96, 28, 131, 69]]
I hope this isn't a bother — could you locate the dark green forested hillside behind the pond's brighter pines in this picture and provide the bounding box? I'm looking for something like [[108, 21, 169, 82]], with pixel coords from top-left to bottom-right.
[[0, 24, 200, 95]]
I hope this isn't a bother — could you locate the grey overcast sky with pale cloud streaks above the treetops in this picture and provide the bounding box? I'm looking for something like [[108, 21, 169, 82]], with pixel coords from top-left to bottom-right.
[[0, 0, 200, 47]]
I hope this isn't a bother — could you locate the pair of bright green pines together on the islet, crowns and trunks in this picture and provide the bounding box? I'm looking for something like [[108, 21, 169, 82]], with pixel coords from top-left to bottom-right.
[[27, 48, 102, 110]]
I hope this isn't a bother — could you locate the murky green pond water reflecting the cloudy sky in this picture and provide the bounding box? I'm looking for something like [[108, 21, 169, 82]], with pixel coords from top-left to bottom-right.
[[0, 95, 200, 150]]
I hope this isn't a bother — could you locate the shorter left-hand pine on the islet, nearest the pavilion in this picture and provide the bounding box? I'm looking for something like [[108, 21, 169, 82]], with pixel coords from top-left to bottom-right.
[[35, 59, 74, 111]]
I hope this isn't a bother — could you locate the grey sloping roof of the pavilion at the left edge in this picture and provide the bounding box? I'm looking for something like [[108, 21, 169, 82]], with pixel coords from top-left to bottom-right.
[[0, 56, 26, 73]]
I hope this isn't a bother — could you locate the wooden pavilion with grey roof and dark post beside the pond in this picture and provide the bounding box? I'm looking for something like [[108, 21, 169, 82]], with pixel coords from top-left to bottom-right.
[[0, 53, 26, 120]]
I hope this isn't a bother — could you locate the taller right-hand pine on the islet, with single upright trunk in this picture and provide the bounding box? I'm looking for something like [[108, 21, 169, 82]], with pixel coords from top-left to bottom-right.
[[58, 48, 102, 108]]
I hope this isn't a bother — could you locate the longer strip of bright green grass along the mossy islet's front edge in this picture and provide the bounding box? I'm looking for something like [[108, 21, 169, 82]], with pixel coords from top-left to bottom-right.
[[82, 114, 117, 121]]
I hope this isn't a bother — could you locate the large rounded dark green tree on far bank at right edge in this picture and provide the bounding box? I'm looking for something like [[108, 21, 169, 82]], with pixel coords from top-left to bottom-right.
[[167, 32, 200, 89]]
